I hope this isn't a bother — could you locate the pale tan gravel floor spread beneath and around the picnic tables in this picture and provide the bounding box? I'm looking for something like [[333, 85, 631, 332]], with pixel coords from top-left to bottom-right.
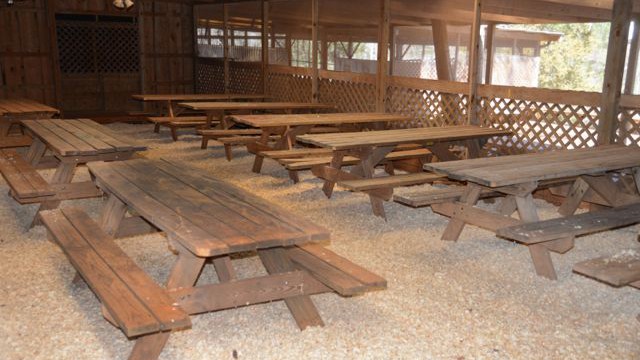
[[0, 124, 640, 360]]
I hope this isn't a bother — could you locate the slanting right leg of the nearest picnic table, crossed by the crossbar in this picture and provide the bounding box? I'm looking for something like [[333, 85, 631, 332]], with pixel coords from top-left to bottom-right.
[[258, 248, 324, 330]]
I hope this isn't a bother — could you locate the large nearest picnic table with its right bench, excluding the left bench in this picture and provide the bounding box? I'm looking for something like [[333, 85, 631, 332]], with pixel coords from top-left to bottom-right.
[[80, 159, 386, 359]]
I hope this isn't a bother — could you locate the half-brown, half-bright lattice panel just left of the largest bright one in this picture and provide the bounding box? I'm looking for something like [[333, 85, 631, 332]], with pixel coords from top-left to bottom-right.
[[386, 86, 467, 128]]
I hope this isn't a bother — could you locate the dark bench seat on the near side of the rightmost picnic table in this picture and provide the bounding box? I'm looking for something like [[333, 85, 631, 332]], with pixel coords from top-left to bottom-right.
[[497, 203, 640, 244]]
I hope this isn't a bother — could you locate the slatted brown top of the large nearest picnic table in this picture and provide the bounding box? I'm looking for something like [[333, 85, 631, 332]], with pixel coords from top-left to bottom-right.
[[88, 159, 329, 257]]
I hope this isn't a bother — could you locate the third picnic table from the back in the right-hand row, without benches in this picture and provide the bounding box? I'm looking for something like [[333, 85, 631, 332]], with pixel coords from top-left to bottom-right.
[[233, 113, 411, 173]]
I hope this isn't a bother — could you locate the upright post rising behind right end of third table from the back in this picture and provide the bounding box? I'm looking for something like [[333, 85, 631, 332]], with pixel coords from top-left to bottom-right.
[[376, 0, 391, 112]]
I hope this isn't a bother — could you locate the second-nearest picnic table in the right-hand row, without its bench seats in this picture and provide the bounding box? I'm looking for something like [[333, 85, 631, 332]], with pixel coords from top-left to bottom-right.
[[297, 125, 510, 217]]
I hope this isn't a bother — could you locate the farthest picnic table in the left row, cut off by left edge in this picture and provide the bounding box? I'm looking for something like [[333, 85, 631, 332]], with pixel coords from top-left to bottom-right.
[[0, 99, 60, 148]]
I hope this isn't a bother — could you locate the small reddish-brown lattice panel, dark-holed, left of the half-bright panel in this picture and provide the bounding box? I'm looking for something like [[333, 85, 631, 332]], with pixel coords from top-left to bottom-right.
[[318, 79, 376, 112]]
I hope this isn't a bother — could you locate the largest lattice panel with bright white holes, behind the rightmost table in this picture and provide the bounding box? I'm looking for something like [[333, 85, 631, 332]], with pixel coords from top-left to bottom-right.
[[479, 98, 599, 154]]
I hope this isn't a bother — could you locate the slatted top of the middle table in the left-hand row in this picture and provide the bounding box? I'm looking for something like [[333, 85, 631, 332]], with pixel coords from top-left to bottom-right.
[[22, 119, 147, 156]]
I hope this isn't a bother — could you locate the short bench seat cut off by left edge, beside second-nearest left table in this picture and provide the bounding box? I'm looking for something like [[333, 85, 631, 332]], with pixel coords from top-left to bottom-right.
[[0, 149, 55, 201]]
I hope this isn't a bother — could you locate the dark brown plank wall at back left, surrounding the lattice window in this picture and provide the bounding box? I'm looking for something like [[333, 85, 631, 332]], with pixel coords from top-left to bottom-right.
[[0, 0, 194, 112]]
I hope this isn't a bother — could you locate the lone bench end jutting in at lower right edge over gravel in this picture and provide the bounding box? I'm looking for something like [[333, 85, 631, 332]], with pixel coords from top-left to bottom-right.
[[573, 254, 640, 287]]
